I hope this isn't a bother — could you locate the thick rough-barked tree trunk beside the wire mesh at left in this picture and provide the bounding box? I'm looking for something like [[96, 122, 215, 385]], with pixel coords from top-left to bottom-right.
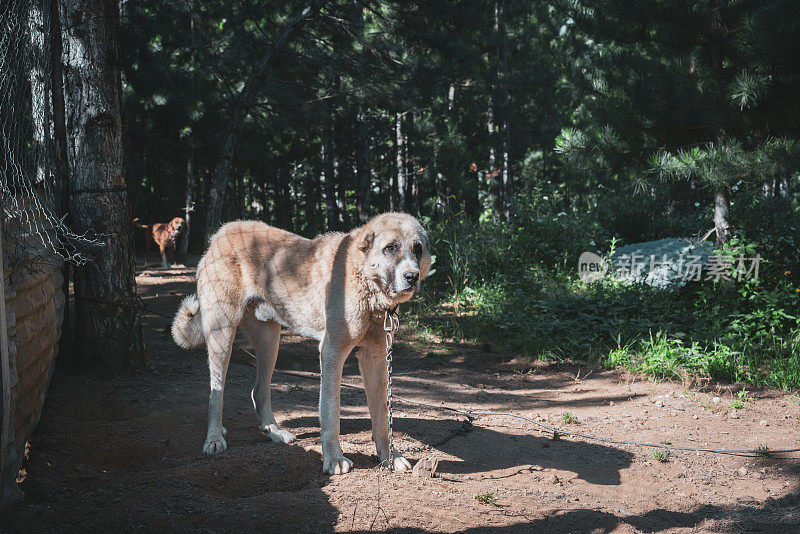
[[62, 0, 146, 370]]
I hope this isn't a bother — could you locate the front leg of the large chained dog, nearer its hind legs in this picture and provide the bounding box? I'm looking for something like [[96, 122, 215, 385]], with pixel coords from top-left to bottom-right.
[[319, 336, 353, 475]]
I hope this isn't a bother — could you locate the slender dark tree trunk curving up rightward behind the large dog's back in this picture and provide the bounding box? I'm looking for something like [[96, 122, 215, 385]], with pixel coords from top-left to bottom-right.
[[206, 0, 326, 243]]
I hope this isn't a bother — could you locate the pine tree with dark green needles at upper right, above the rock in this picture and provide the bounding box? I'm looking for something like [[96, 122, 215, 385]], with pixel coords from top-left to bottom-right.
[[557, 0, 800, 246]]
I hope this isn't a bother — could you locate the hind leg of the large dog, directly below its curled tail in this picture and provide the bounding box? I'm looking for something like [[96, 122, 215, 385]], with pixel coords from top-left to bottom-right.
[[203, 320, 236, 455]]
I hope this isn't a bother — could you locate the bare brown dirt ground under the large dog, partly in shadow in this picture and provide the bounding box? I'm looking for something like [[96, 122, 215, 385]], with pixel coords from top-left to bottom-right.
[[0, 263, 800, 533]]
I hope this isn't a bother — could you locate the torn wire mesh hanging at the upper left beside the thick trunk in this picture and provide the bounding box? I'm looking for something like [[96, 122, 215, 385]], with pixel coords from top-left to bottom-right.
[[0, 0, 100, 277]]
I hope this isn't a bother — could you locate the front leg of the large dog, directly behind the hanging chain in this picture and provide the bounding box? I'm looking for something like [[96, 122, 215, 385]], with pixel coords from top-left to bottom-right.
[[356, 345, 411, 471]]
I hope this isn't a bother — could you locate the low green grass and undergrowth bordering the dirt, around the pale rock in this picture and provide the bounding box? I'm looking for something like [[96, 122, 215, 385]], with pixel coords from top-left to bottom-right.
[[416, 210, 800, 394]]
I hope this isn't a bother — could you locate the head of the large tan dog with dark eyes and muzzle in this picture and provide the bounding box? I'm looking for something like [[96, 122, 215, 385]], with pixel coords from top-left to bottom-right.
[[355, 213, 431, 305]]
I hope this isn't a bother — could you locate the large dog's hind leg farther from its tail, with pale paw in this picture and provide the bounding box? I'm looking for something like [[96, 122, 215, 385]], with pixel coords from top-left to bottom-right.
[[242, 314, 295, 443]]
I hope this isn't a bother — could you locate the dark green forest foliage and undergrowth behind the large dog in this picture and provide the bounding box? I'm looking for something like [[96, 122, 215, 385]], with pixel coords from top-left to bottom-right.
[[120, 0, 800, 394]]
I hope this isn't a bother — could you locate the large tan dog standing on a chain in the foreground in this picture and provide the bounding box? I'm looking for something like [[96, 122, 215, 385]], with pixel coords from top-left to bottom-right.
[[172, 213, 431, 474]]
